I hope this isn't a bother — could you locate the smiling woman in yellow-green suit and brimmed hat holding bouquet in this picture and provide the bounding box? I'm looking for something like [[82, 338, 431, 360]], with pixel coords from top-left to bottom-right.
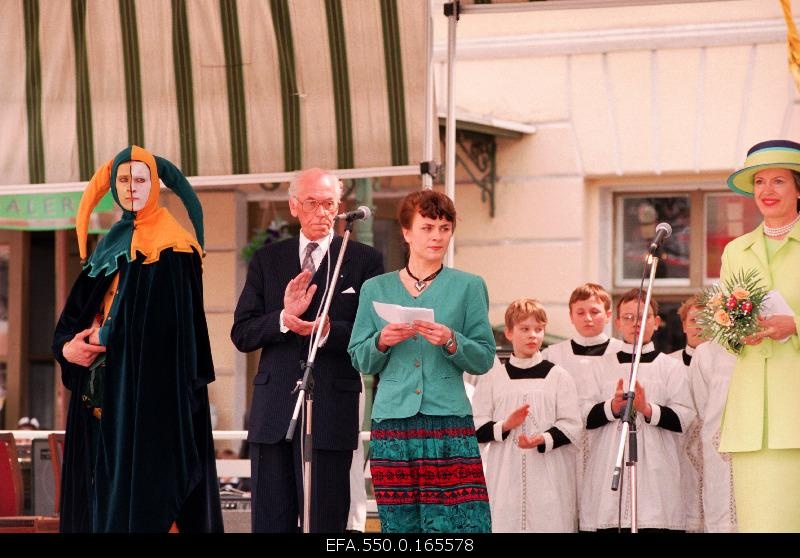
[[719, 140, 800, 532]]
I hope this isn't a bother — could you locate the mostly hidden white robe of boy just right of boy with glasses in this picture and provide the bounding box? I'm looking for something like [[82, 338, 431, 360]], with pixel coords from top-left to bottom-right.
[[669, 345, 703, 533]]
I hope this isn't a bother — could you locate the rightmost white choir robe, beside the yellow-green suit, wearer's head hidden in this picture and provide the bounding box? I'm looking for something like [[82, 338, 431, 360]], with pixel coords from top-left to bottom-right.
[[689, 341, 737, 533]]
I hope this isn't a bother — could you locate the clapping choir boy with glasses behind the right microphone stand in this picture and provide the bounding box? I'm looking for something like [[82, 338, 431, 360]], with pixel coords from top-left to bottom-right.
[[580, 289, 695, 531]]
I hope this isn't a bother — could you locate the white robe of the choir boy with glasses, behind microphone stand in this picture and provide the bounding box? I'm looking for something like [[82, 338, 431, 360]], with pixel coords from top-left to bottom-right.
[[580, 343, 695, 531]]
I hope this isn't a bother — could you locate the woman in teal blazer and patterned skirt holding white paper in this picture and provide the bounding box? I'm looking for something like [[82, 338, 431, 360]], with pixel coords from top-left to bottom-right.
[[348, 190, 495, 533]]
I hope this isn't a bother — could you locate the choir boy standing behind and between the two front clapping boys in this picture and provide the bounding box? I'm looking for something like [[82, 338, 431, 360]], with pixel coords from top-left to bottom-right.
[[542, 283, 622, 528]]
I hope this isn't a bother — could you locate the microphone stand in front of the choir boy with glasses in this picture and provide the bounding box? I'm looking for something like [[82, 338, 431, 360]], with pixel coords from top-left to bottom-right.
[[611, 252, 658, 533]]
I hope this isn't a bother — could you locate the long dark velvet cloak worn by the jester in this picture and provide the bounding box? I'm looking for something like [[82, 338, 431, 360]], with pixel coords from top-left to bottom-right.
[[53, 249, 222, 533]]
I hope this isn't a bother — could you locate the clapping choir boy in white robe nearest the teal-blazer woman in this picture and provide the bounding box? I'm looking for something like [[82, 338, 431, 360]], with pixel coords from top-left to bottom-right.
[[472, 298, 581, 532]]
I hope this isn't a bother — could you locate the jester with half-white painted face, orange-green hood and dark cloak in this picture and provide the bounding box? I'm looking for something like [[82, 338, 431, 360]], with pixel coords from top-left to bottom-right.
[[53, 146, 222, 532]]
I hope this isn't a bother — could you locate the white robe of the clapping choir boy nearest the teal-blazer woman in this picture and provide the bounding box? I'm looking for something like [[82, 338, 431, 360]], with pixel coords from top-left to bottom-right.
[[472, 353, 581, 533]]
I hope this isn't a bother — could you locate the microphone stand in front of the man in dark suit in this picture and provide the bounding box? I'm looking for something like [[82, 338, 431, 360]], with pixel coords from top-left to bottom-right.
[[285, 217, 356, 533]]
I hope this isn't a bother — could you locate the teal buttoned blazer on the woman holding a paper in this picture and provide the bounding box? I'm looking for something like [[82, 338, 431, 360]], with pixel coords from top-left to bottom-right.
[[347, 267, 496, 421]]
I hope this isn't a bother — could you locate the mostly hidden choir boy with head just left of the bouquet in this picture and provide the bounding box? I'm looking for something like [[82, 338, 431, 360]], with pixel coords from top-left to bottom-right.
[[669, 295, 706, 533]]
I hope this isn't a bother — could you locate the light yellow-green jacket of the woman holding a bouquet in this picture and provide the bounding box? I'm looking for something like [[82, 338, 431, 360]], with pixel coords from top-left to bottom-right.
[[719, 221, 800, 452]]
